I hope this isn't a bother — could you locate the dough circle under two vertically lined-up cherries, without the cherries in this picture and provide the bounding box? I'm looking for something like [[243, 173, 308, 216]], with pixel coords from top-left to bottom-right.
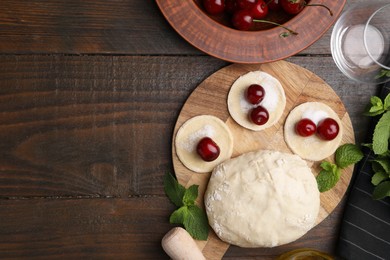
[[227, 71, 286, 131]]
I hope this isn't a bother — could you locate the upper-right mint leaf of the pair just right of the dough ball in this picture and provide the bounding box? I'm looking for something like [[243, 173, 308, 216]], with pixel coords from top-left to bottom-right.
[[335, 144, 363, 169]]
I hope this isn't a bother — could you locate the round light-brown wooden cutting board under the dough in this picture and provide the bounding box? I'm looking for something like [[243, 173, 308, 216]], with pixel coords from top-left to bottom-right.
[[172, 61, 355, 259]]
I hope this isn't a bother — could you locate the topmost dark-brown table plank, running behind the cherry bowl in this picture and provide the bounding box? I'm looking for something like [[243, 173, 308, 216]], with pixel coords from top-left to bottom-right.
[[0, 0, 364, 55]]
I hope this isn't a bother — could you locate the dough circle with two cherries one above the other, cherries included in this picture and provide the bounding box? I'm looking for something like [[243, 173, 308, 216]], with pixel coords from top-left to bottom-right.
[[227, 71, 286, 131]]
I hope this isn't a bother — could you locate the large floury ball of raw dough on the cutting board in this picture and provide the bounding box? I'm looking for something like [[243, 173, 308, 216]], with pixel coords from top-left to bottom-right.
[[204, 150, 320, 247]]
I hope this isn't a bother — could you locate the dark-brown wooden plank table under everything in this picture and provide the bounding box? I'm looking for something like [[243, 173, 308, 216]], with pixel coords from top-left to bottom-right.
[[0, 0, 378, 259]]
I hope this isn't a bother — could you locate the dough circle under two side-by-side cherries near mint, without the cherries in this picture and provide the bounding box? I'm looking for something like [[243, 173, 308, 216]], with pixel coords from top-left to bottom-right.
[[284, 102, 343, 161]]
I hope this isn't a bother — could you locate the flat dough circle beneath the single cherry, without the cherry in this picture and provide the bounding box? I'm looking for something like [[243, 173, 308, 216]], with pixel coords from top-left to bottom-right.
[[175, 115, 233, 173]]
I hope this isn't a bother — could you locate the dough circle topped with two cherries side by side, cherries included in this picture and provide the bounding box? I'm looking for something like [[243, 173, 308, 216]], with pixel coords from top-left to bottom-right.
[[284, 102, 343, 161]]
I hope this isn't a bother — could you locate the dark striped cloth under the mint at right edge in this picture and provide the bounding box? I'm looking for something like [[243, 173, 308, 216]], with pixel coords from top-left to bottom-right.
[[336, 83, 390, 260]]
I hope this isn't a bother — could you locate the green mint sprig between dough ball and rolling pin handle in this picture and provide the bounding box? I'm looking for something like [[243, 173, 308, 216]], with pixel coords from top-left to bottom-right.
[[164, 172, 209, 240]]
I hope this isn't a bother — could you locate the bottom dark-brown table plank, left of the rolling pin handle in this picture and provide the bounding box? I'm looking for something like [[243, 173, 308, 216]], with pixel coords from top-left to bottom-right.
[[0, 196, 173, 259]]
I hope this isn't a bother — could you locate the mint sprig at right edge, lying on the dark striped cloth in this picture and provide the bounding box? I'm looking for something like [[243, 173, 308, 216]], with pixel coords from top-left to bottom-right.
[[365, 93, 390, 199]]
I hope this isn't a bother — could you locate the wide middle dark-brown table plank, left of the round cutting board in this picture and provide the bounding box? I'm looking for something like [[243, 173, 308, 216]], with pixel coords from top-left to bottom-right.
[[0, 56, 223, 197]]
